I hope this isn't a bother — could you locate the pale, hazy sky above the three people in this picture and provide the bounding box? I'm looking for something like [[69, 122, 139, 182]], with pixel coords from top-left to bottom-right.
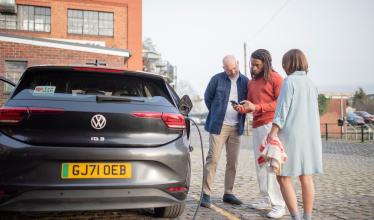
[[143, 0, 374, 96]]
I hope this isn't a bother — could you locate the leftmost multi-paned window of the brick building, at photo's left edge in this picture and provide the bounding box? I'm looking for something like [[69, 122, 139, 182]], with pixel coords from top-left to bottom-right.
[[0, 5, 51, 32]]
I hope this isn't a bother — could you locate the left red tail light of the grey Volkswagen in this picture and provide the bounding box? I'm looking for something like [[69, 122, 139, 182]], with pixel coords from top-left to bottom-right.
[[0, 107, 64, 124]]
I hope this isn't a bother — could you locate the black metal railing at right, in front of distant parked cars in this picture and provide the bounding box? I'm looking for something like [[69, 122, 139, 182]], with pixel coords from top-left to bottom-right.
[[321, 123, 374, 142]]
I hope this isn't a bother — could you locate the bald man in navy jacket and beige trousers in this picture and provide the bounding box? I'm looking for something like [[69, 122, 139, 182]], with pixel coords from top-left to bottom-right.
[[201, 55, 248, 208]]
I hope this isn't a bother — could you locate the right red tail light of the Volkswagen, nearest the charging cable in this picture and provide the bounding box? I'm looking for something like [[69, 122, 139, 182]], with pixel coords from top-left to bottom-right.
[[132, 112, 186, 129]]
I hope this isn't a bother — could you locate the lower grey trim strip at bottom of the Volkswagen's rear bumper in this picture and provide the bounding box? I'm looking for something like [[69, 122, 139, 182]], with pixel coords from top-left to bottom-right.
[[0, 189, 182, 212]]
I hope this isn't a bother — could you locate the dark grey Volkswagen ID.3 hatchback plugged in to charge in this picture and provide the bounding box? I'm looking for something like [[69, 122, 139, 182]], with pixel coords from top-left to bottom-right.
[[0, 66, 192, 217]]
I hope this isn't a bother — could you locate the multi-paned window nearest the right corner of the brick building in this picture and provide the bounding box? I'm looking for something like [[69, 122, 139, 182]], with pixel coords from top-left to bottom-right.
[[68, 9, 113, 36]]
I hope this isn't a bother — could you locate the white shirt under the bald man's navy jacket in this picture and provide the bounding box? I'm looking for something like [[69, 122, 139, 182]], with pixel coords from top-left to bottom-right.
[[223, 73, 239, 126]]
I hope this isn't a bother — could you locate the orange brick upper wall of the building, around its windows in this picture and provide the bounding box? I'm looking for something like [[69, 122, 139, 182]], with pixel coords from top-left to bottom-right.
[[0, 0, 142, 70]]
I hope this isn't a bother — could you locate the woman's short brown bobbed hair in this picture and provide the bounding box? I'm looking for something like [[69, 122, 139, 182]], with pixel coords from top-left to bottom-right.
[[282, 49, 309, 75]]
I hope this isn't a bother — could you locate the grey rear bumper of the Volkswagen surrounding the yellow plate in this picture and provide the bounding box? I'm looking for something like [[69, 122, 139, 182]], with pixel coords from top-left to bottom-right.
[[0, 133, 191, 211]]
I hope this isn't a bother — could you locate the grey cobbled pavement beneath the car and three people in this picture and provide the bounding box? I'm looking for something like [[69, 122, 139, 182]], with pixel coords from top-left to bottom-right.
[[2, 126, 374, 220]]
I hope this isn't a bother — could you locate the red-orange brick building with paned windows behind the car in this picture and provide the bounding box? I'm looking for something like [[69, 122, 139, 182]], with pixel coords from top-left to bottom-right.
[[0, 0, 142, 85]]
